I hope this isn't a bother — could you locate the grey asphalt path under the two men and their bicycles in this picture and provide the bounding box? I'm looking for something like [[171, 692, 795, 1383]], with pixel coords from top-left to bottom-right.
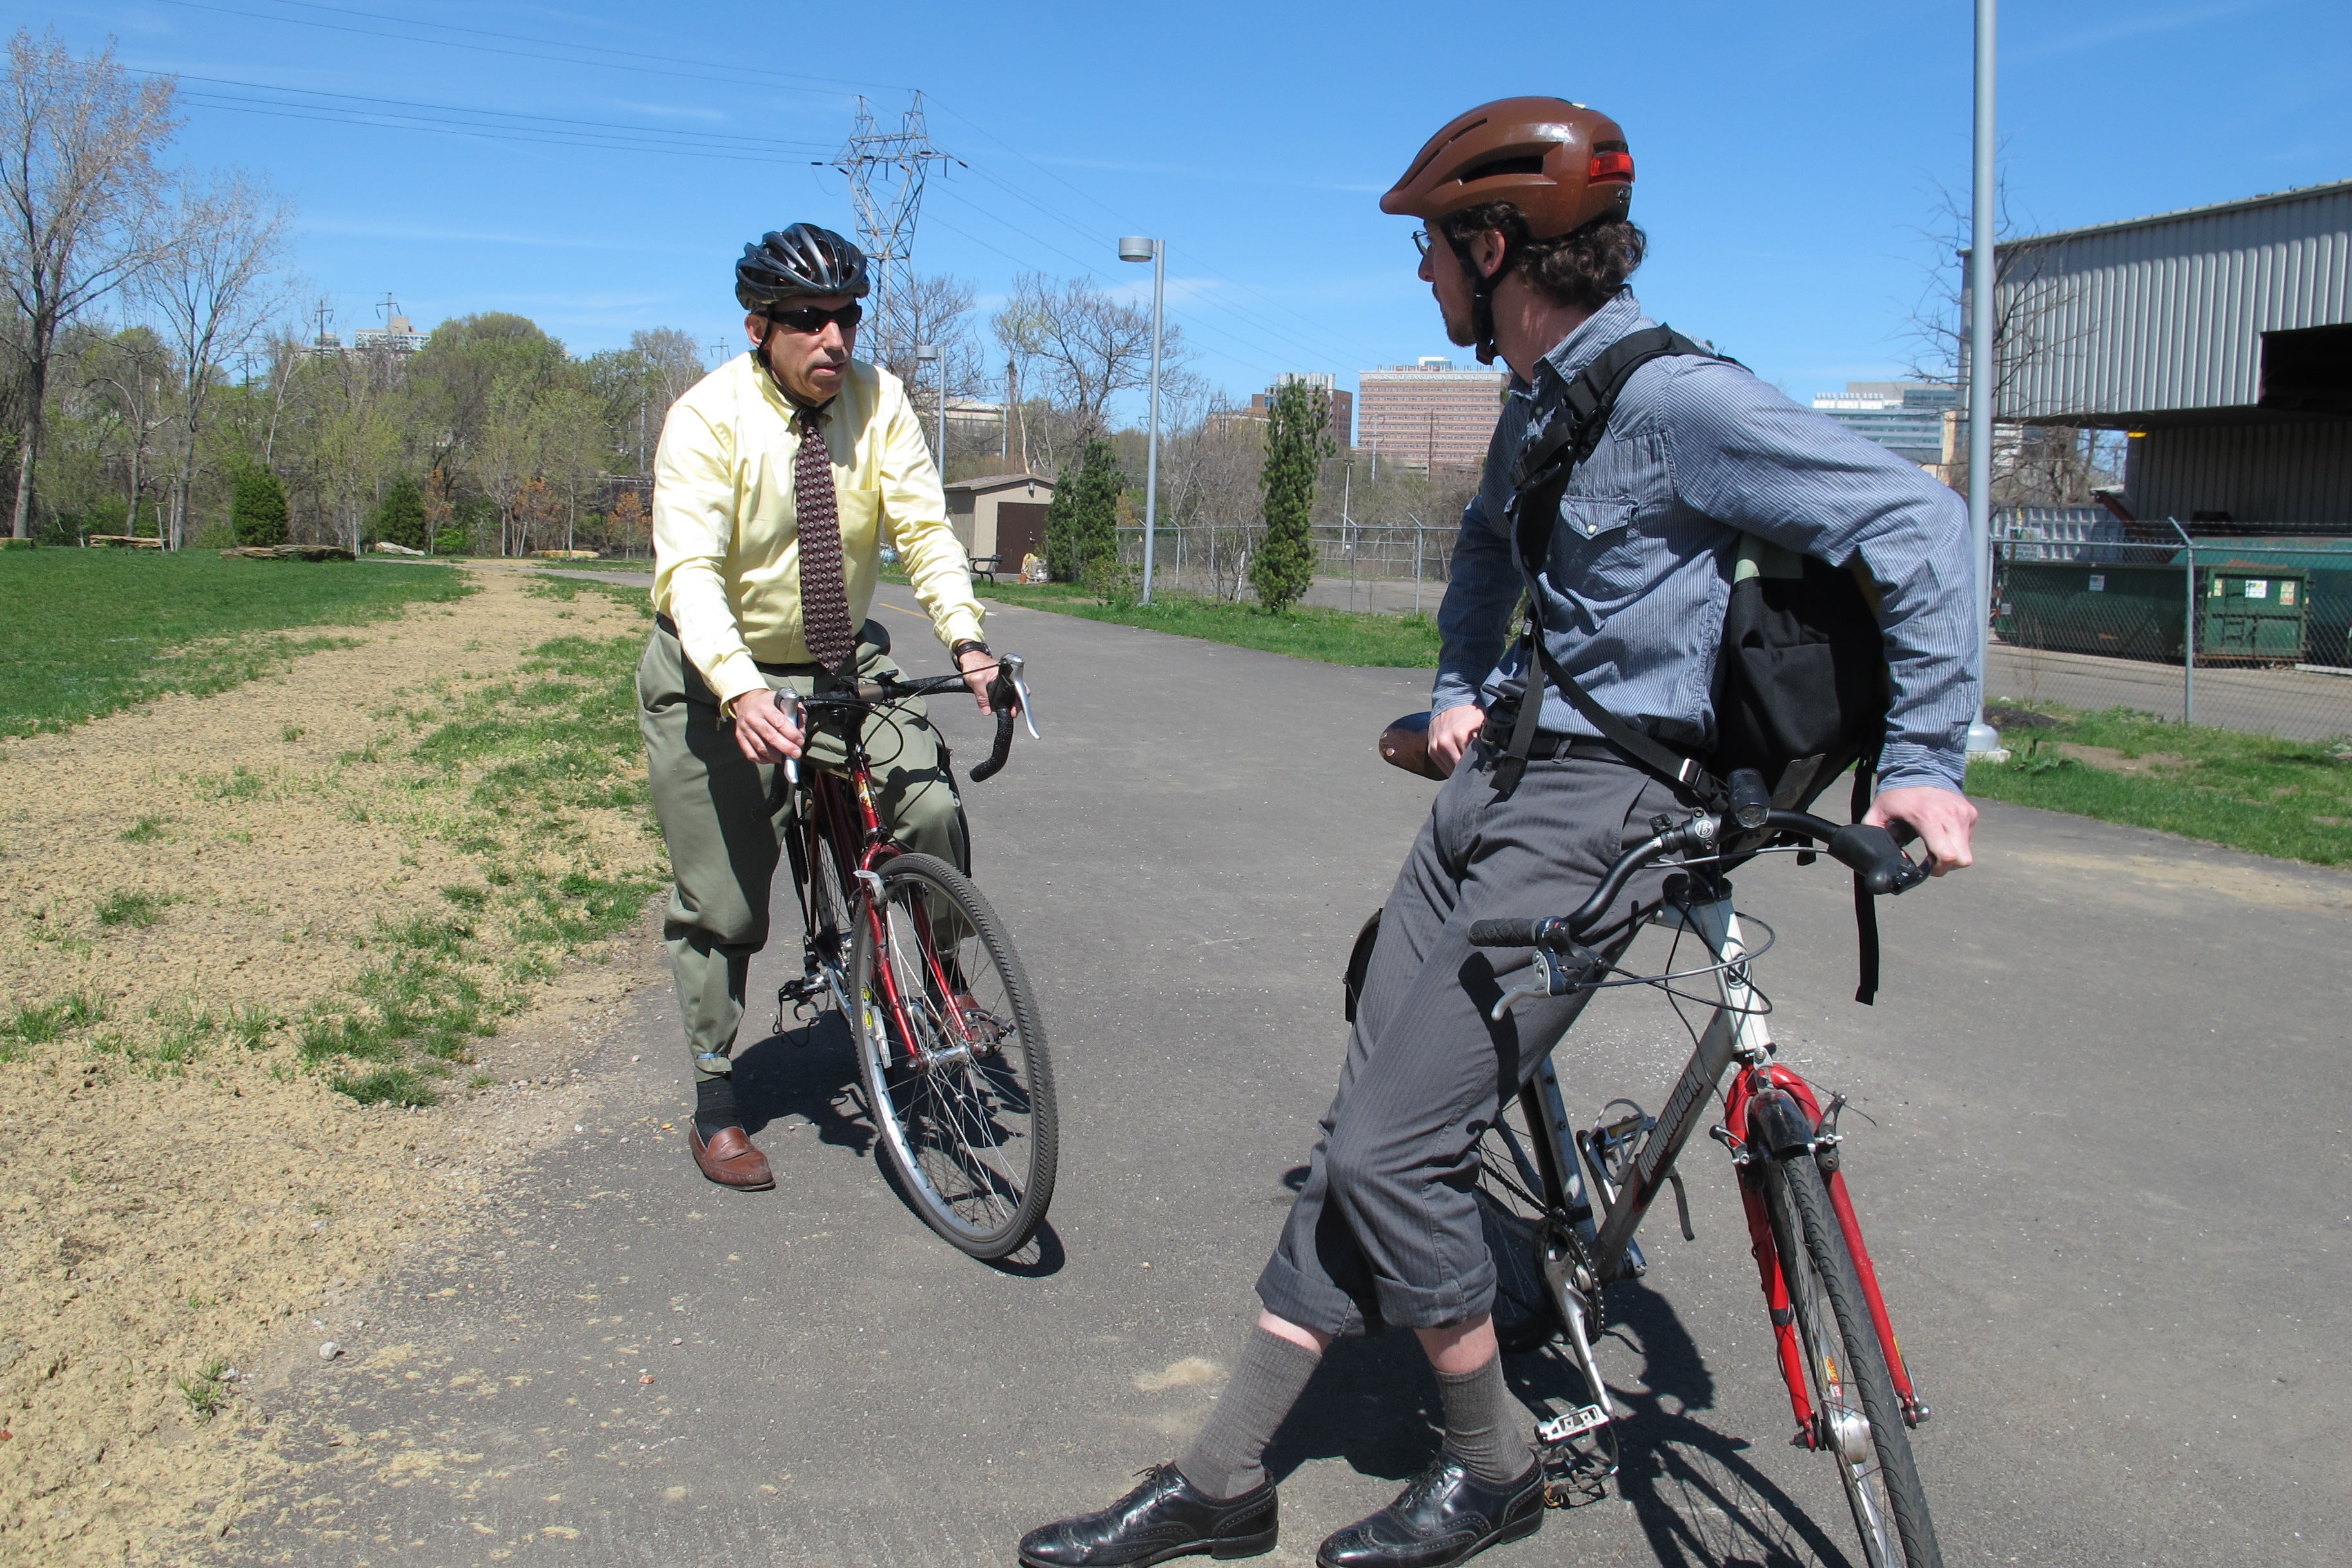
[[233, 590, 2352, 1568]]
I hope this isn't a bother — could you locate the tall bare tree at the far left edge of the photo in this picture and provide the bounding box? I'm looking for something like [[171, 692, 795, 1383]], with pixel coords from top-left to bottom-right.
[[0, 28, 179, 538]]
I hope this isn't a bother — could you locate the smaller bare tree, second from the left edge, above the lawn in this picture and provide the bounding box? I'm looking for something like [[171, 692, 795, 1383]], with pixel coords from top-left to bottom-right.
[[139, 172, 289, 550]]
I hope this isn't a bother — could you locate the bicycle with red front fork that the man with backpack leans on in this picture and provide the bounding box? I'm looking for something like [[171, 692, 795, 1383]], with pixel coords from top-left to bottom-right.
[[1470, 778, 1943, 1568]]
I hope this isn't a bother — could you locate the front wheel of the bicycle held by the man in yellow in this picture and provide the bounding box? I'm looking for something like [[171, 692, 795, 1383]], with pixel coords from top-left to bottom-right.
[[849, 856, 1061, 1258]]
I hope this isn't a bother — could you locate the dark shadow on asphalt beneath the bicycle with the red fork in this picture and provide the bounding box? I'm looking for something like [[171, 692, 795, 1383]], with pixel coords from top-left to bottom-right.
[[1266, 1284, 1854, 1568]]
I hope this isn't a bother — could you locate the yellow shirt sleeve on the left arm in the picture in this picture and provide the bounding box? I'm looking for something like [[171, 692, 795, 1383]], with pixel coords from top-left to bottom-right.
[[654, 400, 767, 705]]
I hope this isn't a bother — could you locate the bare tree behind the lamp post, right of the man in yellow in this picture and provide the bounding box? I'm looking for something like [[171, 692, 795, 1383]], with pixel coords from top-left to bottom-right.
[[992, 273, 1183, 463]]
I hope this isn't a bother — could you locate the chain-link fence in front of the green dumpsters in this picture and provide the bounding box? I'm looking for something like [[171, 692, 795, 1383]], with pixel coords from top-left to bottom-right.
[[1985, 508, 2352, 741]]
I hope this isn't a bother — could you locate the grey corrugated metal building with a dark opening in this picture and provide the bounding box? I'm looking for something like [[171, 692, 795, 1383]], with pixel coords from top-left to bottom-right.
[[1997, 181, 2352, 524]]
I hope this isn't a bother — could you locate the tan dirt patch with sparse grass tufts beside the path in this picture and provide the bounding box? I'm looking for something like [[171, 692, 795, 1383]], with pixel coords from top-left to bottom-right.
[[0, 574, 661, 1563]]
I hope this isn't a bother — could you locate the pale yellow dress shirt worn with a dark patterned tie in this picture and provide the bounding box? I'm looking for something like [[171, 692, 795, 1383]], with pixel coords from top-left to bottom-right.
[[654, 353, 983, 707]]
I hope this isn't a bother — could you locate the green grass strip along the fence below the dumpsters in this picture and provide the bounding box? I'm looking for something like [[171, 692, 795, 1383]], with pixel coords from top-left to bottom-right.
[[1968, 705, 2352, 865]]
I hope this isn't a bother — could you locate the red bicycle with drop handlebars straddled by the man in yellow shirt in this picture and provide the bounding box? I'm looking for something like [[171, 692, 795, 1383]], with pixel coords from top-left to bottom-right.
[[769, 654, 1059, 1258]]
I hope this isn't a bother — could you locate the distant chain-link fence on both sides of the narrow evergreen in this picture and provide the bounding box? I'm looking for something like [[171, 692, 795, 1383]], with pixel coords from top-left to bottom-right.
[[1101, 524, 1458, 614]]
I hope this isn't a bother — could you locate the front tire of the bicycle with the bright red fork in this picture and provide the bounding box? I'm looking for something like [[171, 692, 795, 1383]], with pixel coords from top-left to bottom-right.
[[1764, 1154, 1943, 1568]]
